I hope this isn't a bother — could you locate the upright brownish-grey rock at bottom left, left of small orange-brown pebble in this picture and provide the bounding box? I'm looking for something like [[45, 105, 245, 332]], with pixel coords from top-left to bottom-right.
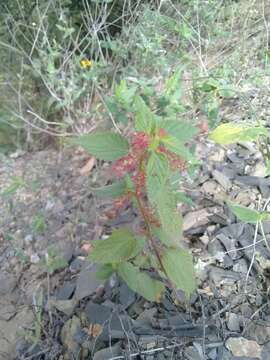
[[60, 316, 81, 358]]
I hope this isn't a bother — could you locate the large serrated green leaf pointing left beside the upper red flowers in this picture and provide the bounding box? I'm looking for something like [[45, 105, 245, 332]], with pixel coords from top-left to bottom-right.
[[71, 132, 129, 161]]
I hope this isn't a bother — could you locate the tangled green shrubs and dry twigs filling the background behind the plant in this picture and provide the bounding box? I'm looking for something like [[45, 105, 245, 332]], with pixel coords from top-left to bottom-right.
[[0, 0, 269, 151]]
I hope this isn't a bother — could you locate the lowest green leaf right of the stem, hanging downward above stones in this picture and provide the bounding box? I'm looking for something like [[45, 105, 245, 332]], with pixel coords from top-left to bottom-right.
[[161, 249, 196, 297]]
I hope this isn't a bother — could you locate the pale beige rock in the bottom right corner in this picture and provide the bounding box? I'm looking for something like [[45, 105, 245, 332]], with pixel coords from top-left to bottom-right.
[[226, 337, 262, 359]]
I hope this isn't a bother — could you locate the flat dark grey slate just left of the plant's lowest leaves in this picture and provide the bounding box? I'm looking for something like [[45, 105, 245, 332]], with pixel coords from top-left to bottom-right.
[[75, 267, 102, 300]]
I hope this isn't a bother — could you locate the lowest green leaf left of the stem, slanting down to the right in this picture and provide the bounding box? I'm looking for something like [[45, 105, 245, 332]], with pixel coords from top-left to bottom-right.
[[118, 263, 165, 302]]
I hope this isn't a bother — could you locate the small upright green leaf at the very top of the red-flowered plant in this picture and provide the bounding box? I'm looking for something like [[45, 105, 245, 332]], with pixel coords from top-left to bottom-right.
[[134, 96, 155, 133]]
